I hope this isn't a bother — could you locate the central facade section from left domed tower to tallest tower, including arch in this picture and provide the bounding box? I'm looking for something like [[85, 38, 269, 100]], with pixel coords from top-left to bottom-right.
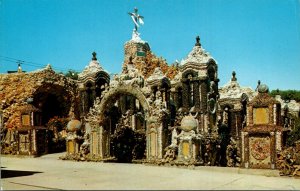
[[61, 34, 223, 165]]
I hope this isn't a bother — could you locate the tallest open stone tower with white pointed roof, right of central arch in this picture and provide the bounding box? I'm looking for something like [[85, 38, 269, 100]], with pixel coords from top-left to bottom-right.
[[171, 36, 219, 133]]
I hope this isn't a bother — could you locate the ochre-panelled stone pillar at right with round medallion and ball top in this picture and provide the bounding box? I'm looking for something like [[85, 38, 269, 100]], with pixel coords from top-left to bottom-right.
[[241, 85, 284, 169]]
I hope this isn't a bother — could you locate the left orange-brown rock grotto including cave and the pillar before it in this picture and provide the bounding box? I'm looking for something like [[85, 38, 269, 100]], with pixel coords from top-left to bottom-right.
[[0, 65, 79, 155]]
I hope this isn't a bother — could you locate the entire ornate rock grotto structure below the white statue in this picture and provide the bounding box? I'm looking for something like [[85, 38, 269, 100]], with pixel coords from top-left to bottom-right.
[[0, 16, 299, 172]]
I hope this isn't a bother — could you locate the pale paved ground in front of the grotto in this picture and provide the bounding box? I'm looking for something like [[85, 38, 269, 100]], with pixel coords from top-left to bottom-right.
[[1, 153, 300, 190]]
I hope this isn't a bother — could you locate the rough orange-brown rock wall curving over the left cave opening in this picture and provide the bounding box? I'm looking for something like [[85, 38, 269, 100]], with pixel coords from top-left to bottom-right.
[[0, 65, 77, 128]]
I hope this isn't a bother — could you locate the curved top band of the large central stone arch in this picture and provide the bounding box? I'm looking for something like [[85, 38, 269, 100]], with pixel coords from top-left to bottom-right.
[[98, 85, 151, 124]]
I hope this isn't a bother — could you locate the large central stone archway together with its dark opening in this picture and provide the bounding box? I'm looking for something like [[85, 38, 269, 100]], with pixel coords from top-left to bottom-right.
[[98, 85, 149, 162]]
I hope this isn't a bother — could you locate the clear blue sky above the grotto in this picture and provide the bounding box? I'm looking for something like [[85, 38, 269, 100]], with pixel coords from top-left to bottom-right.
[[0, 0, 300, 90]]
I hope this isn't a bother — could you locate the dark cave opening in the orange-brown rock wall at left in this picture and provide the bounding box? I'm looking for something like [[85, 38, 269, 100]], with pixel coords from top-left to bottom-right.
[[33, 84, 72, 153]]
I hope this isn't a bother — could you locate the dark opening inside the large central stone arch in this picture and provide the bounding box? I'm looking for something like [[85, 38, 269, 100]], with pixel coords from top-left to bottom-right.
[[104, 93, 146, 163]]
